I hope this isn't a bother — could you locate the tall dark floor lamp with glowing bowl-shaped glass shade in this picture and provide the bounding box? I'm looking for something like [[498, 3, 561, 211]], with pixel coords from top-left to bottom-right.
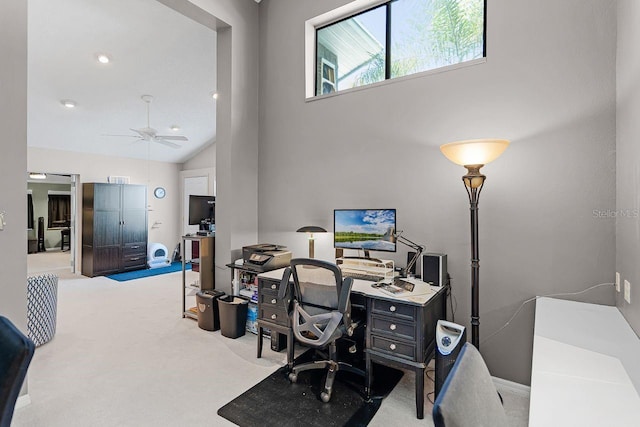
[[440, 139, 509, 350]]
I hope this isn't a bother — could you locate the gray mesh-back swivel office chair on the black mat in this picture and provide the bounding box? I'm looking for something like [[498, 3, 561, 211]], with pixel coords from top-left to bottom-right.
[[279, 258, 364, 403]]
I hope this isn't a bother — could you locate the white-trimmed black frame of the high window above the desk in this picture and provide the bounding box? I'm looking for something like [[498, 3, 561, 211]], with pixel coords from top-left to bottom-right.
[[305, 0, 487, 101]]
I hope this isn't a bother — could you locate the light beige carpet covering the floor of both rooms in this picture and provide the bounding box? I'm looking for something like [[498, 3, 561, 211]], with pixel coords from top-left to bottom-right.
[[12, 260, 529, 427]]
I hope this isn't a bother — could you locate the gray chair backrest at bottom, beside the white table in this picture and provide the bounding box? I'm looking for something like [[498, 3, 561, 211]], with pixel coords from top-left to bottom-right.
[[433, 343, 508, 427]]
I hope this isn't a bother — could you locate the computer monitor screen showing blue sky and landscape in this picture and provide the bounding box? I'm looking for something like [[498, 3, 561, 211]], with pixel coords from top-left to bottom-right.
[[333, 209, 396, 252]]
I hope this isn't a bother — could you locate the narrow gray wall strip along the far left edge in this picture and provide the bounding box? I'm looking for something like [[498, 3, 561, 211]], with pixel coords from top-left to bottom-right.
[[0, 0, 27, 332]]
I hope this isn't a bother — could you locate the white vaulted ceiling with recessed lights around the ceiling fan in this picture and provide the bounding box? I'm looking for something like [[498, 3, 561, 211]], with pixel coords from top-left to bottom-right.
[[27, 0, 216, 163]]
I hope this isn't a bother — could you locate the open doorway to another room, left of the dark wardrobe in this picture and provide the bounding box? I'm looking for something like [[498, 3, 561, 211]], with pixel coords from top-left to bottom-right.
[[27, 172, 78, 276]]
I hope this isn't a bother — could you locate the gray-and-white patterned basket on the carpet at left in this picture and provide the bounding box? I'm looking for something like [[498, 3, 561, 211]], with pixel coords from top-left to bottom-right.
[[27, 274, 58, 347]]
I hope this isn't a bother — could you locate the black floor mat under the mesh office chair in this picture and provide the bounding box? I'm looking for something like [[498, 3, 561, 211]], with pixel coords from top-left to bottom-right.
[[218, 350, 403, 427]]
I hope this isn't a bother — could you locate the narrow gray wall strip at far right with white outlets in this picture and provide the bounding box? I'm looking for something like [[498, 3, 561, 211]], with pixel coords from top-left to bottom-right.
[[615, 0, 640, 334]]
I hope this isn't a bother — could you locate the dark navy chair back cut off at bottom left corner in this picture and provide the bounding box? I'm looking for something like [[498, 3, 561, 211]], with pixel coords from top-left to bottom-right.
[[0, 316, 35, 427]]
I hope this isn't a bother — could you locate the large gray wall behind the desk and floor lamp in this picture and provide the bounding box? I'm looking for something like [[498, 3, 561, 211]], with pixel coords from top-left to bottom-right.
[[258, 0, 616, 384]]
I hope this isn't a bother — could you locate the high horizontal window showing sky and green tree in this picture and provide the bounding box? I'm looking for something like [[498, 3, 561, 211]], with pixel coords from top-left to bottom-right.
[[315, 0, 486, 95]]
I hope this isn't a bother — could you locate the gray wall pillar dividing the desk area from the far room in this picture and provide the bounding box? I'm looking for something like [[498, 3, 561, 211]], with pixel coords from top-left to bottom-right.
[[158, 0, 259, 292]]
